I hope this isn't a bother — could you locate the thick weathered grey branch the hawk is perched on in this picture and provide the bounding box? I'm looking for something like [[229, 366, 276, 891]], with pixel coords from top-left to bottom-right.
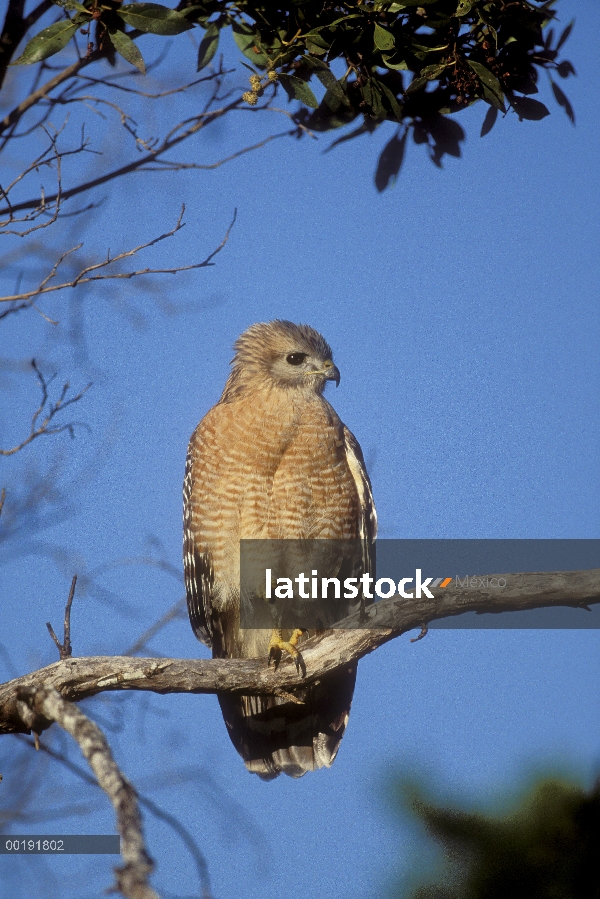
[[0, 569, 600, 733]]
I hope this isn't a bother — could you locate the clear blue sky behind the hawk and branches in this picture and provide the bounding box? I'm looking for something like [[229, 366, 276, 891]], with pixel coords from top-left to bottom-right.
[[0, 0, 600, 899]]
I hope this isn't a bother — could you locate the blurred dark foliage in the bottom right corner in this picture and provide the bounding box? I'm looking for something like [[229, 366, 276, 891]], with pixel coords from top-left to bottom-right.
[[398, 779, 600, 899]]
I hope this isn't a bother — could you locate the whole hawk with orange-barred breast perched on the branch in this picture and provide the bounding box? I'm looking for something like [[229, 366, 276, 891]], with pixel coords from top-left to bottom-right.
[[183, 321, 377, 780]]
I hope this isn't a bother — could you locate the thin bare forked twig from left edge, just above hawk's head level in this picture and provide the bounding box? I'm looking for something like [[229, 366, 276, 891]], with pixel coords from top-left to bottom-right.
[[0, 205, 237, 308]]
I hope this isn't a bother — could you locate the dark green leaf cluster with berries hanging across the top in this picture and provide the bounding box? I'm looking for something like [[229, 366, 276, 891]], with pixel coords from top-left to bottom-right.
[[8, 0, 575, 190]]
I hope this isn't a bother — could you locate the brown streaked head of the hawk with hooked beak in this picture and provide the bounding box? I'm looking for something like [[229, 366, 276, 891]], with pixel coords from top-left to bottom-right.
[[221, 319, 340, 402]]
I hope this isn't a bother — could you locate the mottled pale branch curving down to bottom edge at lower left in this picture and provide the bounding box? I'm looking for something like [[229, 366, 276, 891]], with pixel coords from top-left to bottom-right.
[[17, 686, 158, 899]]
